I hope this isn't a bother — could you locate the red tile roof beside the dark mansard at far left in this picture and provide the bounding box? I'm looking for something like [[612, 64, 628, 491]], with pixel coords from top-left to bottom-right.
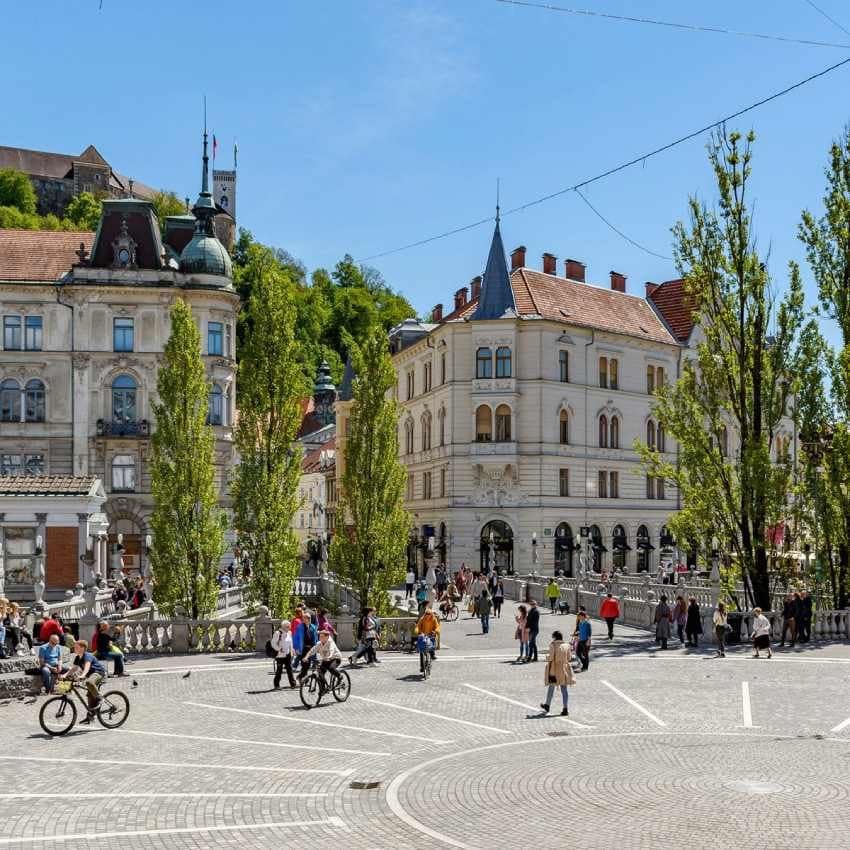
[[0, 230, 94, 281]]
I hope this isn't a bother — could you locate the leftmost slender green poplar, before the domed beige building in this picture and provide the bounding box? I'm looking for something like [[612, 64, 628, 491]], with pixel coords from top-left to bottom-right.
[[151, 300, 224, 619]]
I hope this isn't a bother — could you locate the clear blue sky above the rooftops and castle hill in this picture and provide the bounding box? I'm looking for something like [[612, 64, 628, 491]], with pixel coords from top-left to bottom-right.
[[6, 0, 850, 342]]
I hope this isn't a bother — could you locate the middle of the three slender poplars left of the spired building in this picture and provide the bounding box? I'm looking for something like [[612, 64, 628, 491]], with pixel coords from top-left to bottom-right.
[[233, 244, 307, 617]]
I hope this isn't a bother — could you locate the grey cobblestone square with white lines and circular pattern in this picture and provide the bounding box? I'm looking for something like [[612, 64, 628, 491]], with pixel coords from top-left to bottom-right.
[[0, 609, 850, 850]]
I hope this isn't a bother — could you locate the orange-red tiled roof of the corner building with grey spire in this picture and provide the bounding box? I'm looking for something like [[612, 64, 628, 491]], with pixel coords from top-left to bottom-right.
[[443, 268, 675, 344]]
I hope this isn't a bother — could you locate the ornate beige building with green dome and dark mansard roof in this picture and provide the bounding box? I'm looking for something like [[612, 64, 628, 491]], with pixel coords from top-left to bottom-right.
[[0, 138, 238, 588]]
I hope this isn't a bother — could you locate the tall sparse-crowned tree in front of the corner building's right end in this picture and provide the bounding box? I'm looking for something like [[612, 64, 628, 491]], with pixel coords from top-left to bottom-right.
[[638, 132, 803, 609]]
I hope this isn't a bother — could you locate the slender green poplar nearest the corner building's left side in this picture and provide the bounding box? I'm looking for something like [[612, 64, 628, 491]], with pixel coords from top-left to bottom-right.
[[330, 326, 411, 608]]
